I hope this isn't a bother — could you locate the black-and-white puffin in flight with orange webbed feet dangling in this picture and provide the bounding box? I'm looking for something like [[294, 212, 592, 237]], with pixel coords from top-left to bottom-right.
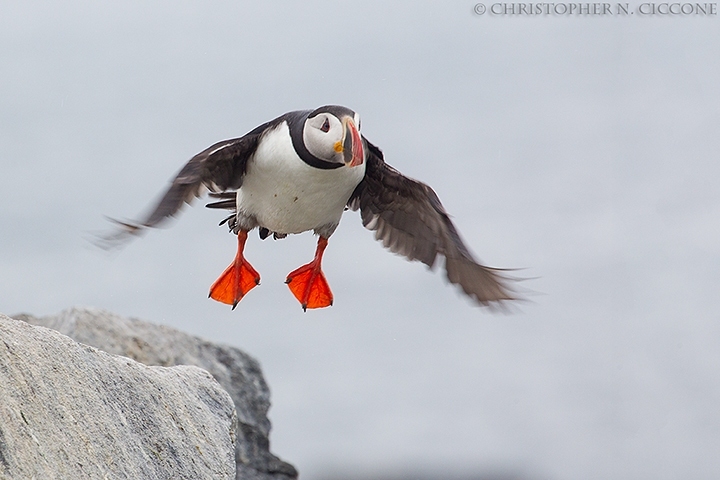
[[104, 105, 518, 310]]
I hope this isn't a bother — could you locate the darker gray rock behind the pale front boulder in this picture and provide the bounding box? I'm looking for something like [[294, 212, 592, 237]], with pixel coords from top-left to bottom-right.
[[14, 308, 298, 480]]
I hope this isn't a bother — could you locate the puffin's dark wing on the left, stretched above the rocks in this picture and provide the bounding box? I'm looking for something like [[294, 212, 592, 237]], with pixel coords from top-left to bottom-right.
[[97, 116, 285, 248]]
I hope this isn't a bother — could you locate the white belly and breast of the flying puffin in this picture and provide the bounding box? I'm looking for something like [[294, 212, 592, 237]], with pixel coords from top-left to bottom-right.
[[237, 123, 365, 234]]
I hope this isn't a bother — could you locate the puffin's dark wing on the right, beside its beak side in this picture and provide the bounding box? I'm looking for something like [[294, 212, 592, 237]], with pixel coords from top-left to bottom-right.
[[348, 139, 518, 306]]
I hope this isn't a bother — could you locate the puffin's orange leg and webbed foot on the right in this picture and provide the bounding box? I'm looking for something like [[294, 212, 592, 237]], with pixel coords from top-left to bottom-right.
[[285, 237, 333, 311]]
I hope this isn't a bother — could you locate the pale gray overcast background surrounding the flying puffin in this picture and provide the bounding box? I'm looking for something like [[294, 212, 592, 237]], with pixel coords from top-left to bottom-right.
[[0, 1, 720, 480]]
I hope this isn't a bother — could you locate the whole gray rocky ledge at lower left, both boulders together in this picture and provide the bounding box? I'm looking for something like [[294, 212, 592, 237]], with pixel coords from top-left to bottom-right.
[[0, 308, 297, 480]]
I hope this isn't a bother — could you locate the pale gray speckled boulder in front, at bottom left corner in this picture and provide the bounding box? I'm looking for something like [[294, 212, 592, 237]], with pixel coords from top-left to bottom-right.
[[0, 315, 237, 479]]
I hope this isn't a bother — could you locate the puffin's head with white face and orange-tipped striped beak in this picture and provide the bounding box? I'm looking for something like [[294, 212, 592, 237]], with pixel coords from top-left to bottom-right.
[[303, 105, 365, 167]]
